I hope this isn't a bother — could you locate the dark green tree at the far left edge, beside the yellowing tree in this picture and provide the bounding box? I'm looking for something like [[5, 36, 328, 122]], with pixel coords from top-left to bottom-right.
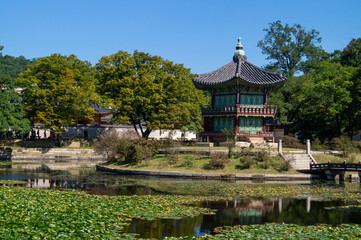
[[0, 46, 30, 134]]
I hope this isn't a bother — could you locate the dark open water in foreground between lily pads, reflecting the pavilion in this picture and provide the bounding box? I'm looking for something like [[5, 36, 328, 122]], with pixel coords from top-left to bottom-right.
[[124, 198, 361, 238]]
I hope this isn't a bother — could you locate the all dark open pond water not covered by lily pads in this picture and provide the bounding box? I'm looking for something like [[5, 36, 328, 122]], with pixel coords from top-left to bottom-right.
[[0, 164, 361, 238]]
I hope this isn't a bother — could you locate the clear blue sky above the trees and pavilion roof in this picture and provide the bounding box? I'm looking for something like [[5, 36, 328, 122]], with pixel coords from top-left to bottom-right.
[[0, 0, 361, 73]]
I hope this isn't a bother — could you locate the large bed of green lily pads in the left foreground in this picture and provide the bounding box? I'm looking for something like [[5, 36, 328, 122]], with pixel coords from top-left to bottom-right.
[[0, 187, 212, 239]]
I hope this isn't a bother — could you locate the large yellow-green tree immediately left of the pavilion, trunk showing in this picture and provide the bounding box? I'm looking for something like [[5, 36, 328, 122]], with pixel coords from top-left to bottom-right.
[[96, 51, 205, 138]]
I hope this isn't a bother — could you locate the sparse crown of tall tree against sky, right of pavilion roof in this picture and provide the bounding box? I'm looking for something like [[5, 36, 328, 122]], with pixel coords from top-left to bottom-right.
[[258, 20, 327, 77]]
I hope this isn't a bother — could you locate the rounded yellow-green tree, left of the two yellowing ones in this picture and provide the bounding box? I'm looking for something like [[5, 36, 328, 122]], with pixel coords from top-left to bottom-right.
[[17, 54, 98, 133]]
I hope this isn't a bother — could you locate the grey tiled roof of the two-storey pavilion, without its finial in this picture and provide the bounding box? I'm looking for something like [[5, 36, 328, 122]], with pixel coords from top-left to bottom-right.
[[193, 56, 286, 85]]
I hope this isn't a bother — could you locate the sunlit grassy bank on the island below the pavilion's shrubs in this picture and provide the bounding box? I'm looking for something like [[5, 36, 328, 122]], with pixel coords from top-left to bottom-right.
[[108, 154, 297, 174]]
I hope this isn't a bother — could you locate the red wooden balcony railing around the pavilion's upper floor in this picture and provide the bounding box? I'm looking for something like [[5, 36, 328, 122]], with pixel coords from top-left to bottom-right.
[[202, 104, 277, 117]]
